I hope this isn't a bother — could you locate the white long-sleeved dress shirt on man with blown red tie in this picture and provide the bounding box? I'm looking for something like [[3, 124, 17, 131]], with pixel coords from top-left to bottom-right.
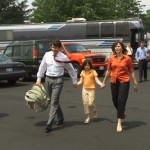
[[37, 51, 77, 84]]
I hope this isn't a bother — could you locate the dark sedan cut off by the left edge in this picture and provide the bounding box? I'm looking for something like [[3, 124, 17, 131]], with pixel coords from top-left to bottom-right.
[[0, 54, 26, 84]]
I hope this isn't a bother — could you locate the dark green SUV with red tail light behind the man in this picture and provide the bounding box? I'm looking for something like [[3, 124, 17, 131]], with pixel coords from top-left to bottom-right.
[[3, 40, 51, 78]]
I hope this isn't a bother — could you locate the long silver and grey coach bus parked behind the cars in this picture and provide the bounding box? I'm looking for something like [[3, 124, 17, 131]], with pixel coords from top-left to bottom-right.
[[0, 18, 147, 61]]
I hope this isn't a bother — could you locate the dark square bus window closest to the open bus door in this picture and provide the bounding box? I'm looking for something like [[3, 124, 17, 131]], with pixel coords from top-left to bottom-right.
[[116, 22, 129, 37]]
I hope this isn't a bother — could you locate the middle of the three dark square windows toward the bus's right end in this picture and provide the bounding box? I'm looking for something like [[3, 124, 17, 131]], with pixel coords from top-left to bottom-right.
[[101, 23, 114, 37]]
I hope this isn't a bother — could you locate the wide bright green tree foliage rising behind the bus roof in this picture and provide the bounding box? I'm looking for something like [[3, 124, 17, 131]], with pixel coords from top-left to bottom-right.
[[33, 0, 143, 22]]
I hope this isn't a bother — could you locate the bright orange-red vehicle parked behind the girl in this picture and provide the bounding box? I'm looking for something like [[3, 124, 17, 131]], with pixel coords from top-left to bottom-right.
[[61, 42, 107, 76]]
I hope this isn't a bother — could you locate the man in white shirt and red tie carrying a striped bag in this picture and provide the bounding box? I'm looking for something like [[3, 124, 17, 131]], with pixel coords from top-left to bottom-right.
[[36, 39, 77, 133]]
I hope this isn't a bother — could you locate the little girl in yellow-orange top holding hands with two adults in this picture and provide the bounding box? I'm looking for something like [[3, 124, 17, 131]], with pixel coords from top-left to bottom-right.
[[77, 59, 103, 124]]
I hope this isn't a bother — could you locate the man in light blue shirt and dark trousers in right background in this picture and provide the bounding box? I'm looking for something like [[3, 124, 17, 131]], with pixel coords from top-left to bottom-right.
[[135, 41, 149, 83]]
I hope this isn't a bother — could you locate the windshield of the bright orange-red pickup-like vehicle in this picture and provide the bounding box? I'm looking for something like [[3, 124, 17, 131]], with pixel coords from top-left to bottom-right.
[[64, 44, 87, 53]]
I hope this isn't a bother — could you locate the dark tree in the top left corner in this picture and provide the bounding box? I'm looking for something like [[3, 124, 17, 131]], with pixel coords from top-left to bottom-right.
[[0, 0, 31, 24]]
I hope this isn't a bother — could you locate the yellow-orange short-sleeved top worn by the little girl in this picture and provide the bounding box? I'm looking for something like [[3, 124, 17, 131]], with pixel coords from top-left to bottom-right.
[[80, 69, 98, 89]]
